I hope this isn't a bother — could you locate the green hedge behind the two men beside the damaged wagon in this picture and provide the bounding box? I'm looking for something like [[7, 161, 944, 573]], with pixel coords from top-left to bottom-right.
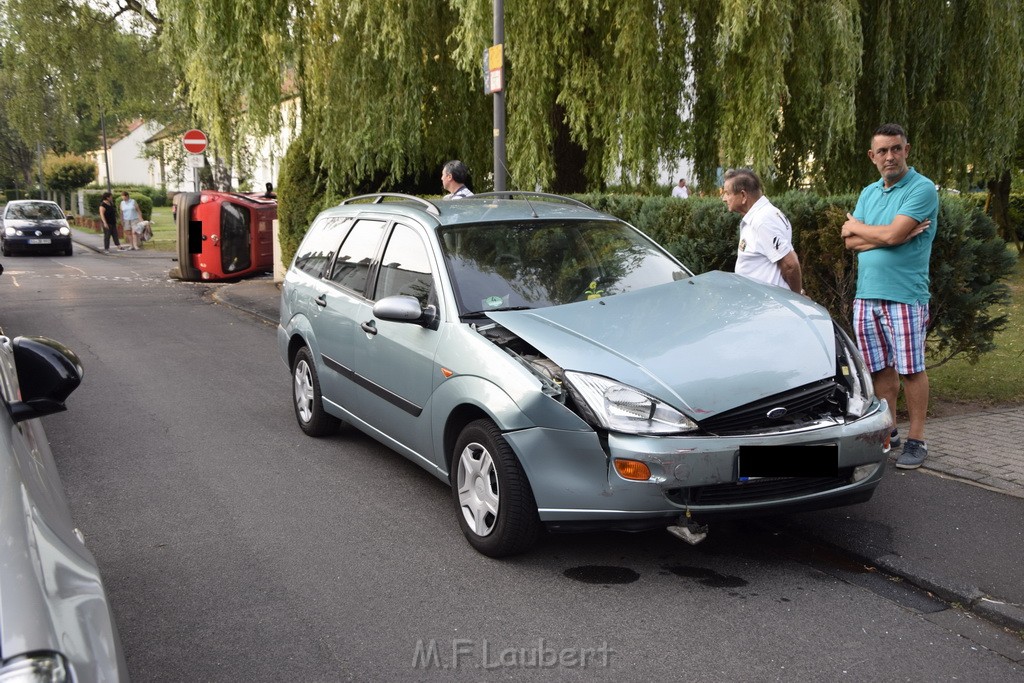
[[578, 191, 1015, 365]]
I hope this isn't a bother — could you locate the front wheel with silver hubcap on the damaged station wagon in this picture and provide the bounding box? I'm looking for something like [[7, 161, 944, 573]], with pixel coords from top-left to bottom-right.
[[452, 420, 541, 557]]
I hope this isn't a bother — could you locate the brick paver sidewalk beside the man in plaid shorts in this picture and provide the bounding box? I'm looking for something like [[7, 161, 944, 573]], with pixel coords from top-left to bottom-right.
[[893, 408, 1024, 498]]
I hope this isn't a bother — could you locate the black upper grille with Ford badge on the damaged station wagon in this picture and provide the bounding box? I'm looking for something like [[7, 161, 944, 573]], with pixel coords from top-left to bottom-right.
[[698, 379, 843, 434]]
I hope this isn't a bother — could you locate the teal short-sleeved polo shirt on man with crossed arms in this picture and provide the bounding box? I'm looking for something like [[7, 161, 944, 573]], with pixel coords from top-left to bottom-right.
[[853, 167, 939, 303]]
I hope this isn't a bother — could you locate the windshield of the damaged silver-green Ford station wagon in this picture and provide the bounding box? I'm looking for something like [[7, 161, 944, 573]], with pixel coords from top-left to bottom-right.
[[439, 220, 692, 316]]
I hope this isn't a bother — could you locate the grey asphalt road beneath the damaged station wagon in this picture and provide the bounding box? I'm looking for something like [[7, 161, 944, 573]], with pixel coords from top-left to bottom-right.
[[0, 250, 1022, 681]]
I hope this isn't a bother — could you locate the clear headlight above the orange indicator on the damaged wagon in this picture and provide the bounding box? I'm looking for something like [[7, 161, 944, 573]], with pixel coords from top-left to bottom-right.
[[565, 371, 698, 434]]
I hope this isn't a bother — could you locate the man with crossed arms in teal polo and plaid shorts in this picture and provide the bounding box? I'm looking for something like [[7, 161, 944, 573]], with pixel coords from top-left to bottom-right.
[[843, 123, 939, 469]]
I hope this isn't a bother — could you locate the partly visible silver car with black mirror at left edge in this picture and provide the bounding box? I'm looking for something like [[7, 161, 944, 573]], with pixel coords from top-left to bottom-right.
[[0, 337, 128, 683]]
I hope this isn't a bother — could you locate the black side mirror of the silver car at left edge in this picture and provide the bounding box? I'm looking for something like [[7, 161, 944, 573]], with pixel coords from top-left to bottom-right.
[[7, 337, 83, 422]]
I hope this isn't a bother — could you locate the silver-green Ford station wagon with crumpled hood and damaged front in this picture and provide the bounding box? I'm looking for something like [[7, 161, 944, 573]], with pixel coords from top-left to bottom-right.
[[278, 193, 892, 557]]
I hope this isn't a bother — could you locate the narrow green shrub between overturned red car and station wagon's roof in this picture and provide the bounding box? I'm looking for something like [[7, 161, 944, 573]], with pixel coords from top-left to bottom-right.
[[276, 131, 328, 265]]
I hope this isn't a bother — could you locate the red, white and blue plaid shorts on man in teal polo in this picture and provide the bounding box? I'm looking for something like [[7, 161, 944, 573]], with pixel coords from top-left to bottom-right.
[[853, 299, 929, 375]]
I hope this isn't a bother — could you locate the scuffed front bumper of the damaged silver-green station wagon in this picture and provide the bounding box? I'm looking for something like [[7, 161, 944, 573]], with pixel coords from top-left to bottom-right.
[[505, 402, 892, 529]]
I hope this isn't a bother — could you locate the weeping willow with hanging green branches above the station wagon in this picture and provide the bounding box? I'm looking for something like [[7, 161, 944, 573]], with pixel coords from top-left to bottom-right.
[[153, 0, 1024, 198]]
